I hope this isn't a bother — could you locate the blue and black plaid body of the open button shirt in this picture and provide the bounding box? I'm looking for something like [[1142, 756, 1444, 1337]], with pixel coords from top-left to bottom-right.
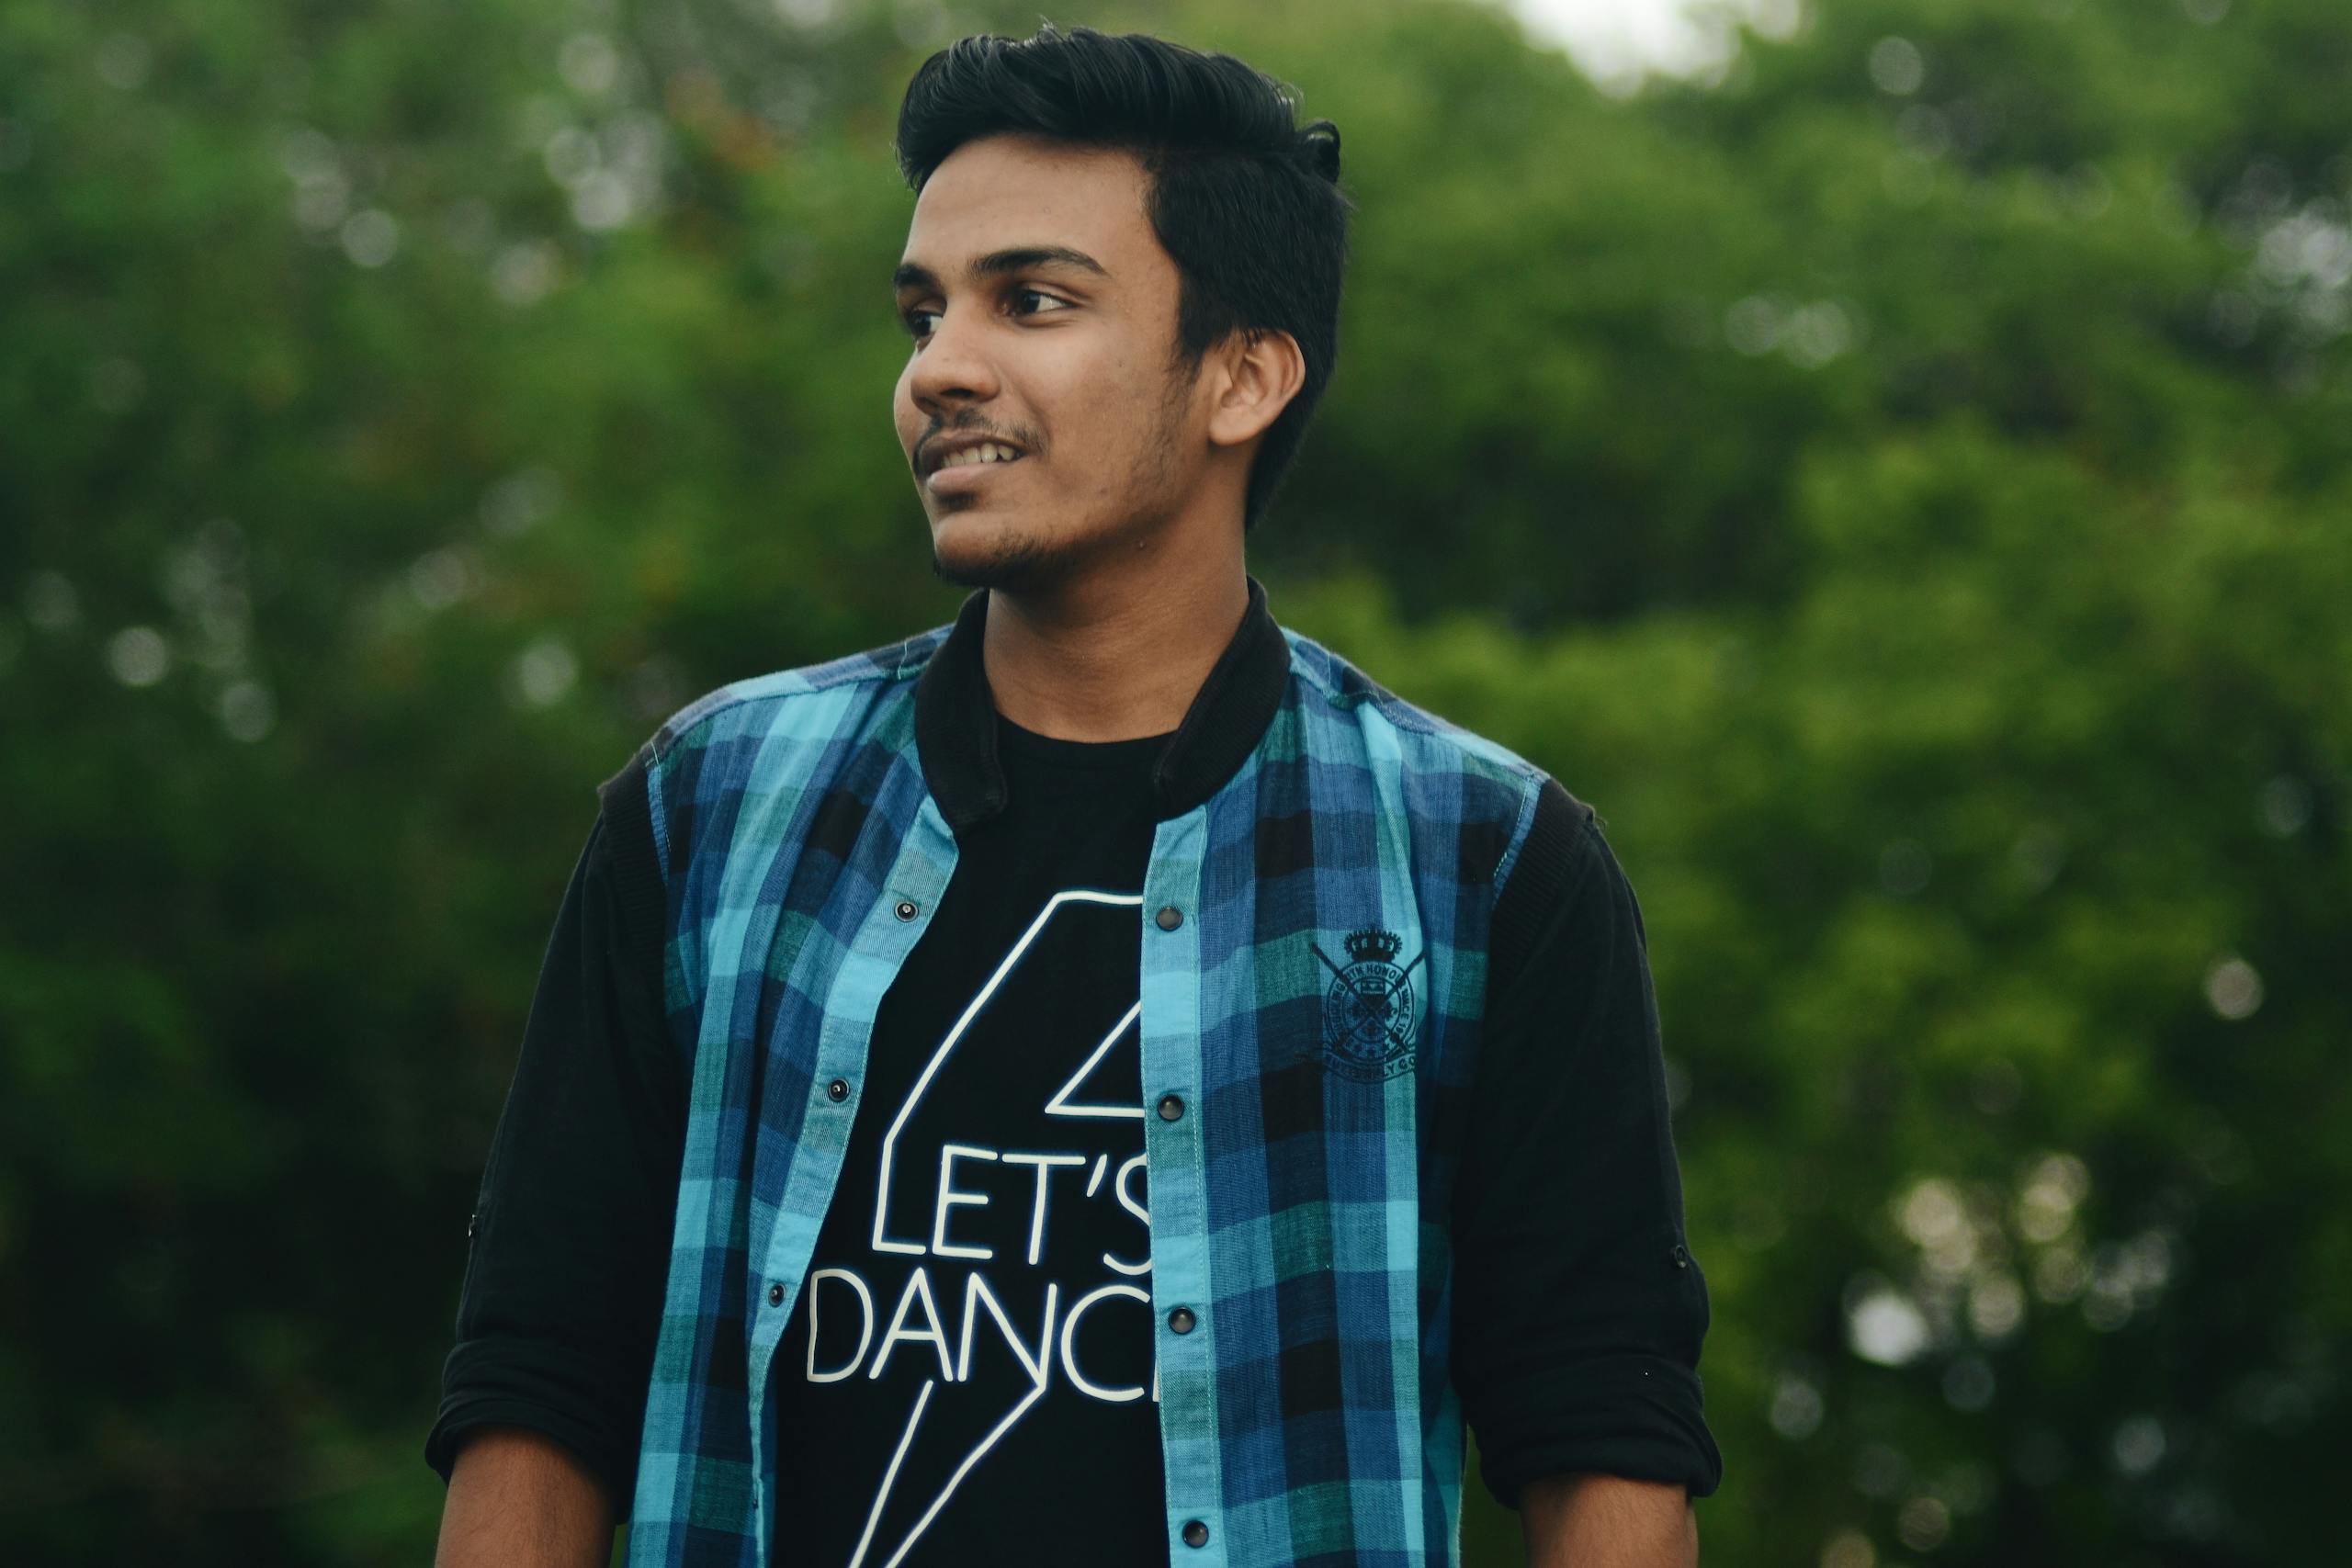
[[628, 627, 1543, 1568]]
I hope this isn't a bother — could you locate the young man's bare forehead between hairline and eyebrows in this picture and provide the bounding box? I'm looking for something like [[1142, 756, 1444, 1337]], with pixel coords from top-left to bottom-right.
[[903, 136, 1164, 280]]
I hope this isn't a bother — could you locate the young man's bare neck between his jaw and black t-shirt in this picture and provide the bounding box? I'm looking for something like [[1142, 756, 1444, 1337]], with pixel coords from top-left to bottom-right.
[[981, 536, 1249, 740]]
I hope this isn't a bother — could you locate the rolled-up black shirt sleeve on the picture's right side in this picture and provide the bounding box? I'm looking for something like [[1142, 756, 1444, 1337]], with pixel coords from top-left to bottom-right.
[[1453, 778, 1722, 1506]]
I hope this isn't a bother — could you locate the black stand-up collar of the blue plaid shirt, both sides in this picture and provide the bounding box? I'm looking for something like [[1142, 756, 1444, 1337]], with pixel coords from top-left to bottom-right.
[[915, 579, 1291, 832]]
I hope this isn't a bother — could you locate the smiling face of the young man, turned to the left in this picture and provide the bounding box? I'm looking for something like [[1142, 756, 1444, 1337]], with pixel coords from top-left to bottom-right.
[[894, 136, 1209, 590]]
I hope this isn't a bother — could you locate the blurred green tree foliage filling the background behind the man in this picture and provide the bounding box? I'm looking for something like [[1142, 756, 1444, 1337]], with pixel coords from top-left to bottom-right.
[[0, 0, 2352, 1568]]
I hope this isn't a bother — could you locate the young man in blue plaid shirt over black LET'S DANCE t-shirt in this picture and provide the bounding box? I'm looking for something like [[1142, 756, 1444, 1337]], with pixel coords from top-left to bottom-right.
[[428, 28, 1719, 1568]]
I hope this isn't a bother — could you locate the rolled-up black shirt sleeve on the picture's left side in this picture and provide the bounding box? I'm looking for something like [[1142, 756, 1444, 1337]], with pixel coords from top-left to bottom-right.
[[425, 764, 684, 1518]]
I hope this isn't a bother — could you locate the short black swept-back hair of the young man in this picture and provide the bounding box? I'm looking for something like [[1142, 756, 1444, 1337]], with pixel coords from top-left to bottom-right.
[[899, 21, 1352, 531]]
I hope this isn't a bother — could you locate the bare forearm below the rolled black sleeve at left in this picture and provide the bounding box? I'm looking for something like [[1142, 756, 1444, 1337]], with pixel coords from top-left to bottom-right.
[[433, 1427, 612, 1568]]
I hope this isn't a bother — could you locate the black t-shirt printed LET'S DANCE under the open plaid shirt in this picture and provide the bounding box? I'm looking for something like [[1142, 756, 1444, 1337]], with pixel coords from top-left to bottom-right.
[[774, 719, 1164, 1568]]
